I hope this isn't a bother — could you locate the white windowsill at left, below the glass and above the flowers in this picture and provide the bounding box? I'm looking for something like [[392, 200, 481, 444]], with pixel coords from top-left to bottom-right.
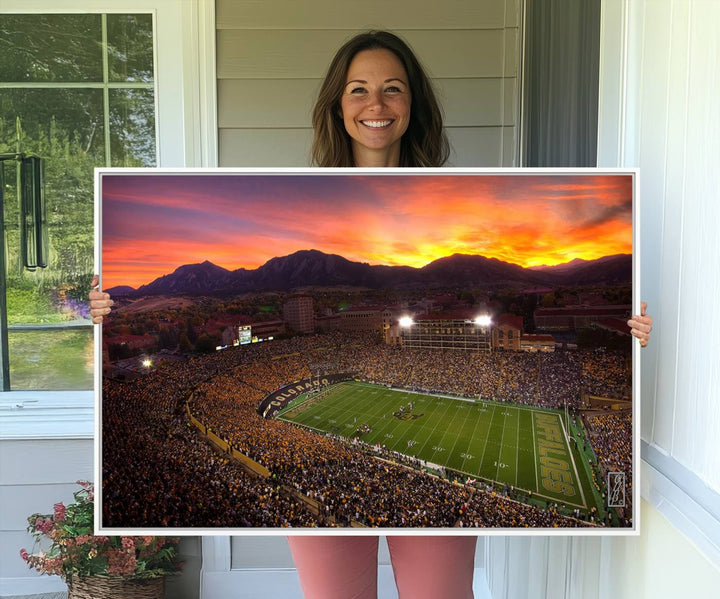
[[0, 391, 95, 440]]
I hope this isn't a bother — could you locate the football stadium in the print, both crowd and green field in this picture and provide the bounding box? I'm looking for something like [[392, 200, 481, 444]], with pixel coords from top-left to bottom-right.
[[101, 332, 632, 528]]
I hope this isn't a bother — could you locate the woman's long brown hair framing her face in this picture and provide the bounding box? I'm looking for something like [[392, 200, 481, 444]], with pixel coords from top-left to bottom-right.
[[312, 31, 450, 167]]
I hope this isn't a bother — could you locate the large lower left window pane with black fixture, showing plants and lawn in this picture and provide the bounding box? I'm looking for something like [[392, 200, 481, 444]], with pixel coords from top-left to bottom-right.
[[0, 89, 97, 390]]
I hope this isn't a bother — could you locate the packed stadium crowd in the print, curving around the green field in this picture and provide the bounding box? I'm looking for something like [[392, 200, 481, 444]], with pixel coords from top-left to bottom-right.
[[102, 333, 630, 528]]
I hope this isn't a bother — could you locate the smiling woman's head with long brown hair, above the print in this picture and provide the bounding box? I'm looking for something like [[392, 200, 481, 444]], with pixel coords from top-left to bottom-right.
[[312, 31, 450, 167]]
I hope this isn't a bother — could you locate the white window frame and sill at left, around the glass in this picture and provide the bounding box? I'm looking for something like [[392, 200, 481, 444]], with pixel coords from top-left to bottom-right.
[[0, 0, 217, 442]]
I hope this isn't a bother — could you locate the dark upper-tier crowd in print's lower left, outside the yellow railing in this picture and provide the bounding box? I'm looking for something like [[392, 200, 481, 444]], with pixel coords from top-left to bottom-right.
[[102, 359, 316, 527]]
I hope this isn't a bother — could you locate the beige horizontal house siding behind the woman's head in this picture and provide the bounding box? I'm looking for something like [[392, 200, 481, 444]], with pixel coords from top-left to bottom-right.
[[216, 0, 521, 167]]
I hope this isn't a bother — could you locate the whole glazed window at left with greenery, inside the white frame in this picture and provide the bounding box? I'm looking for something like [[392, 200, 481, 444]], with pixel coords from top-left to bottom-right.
[[0, 14, 157, 390]]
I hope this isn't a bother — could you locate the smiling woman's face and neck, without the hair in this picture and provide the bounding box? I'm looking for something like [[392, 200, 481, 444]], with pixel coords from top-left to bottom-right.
[[340, 49, 412, 166]]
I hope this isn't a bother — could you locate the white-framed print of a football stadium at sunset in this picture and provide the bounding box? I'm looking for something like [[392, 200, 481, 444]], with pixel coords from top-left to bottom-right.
[[96, 169, 639, 534]]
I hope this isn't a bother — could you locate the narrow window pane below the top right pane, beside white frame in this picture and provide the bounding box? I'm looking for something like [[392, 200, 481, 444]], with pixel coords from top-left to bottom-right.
[[110, 89, 155, 167]]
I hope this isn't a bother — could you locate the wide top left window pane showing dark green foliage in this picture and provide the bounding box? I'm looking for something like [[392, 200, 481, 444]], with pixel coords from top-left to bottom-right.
[[0, 14, 103, 82]]
